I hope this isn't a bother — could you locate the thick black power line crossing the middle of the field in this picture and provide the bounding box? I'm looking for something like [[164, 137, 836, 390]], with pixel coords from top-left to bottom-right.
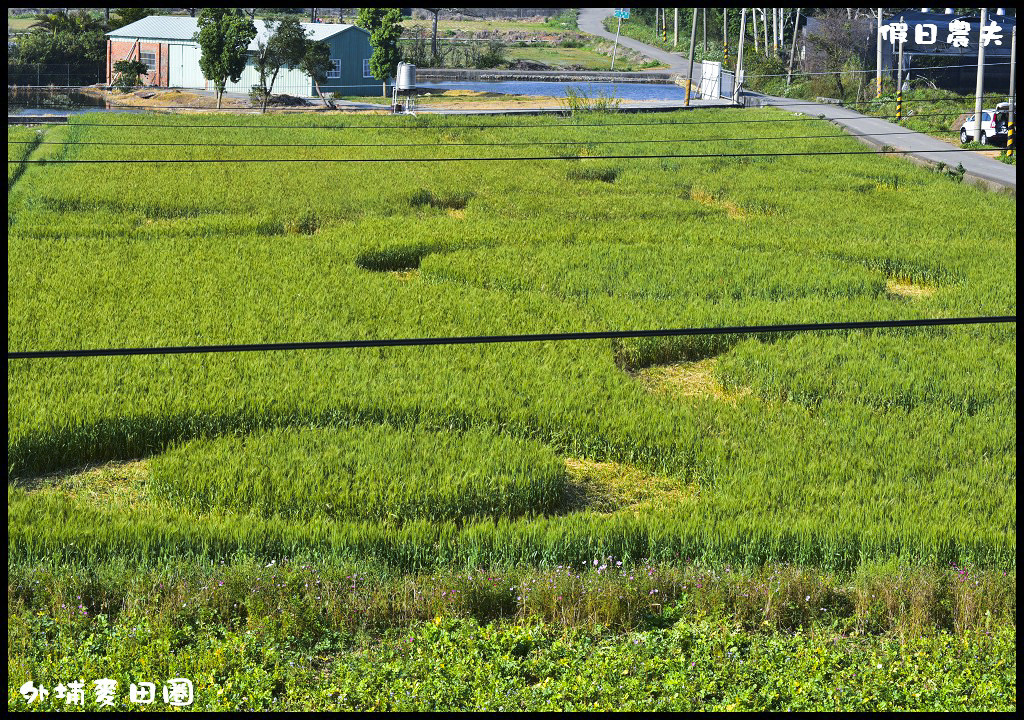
[[7, 315, 1017, 361]]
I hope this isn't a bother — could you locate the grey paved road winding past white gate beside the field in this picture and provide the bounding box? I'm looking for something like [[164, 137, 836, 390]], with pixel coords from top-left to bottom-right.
[[579, 7, 1017, 192]]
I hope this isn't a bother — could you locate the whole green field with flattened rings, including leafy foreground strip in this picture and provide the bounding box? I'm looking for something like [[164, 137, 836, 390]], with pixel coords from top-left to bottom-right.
[[7, 110, 1017, 710]]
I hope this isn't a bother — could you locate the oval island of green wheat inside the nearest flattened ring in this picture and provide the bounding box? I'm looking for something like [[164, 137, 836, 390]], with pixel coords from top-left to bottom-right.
[[152, 427, 565, 523]]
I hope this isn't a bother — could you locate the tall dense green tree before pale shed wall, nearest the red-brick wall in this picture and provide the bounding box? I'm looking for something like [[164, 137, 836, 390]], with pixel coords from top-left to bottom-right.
[[193, 7, 256, 109]]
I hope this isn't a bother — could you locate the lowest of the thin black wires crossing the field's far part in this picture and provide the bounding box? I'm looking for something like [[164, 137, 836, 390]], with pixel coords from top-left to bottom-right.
[[7, 147, 991, 165]]
